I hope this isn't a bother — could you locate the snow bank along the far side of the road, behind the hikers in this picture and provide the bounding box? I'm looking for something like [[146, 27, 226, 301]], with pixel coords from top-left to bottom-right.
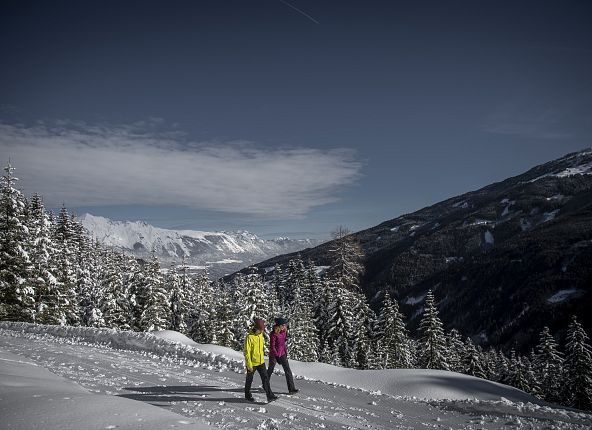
[[0, 322, 544, 404]]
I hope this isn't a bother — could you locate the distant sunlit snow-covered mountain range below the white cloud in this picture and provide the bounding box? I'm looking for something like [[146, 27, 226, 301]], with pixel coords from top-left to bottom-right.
[[78, 213, 320, 276]]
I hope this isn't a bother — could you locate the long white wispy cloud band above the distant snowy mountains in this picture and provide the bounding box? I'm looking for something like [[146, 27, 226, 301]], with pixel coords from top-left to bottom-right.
[[0, 118, 362, 218]]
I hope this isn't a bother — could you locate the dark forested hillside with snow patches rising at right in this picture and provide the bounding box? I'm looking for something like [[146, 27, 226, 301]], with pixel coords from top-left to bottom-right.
[[235, 150, 592, 351]]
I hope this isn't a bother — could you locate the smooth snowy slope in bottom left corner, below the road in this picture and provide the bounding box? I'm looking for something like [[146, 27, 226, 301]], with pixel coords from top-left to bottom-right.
[[0, 351, 213, 430]]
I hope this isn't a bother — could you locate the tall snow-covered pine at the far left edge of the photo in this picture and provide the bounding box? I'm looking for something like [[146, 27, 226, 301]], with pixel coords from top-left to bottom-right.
[[0, 163, 35, 322]]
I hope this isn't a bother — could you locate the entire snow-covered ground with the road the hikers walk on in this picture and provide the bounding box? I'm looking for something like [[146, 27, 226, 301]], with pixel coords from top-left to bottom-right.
[[0, 323, 592, 429]]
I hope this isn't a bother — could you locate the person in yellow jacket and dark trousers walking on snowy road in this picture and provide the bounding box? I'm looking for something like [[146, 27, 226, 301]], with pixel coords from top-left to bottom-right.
[[243, 318, 277, 402]]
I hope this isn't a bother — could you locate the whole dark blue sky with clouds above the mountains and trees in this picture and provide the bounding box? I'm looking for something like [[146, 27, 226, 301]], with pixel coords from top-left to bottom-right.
[[0, 0, 592, 237]]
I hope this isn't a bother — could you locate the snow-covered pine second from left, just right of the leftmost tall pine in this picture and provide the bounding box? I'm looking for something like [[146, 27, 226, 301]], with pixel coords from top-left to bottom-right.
[[27, 194, 58, 324]]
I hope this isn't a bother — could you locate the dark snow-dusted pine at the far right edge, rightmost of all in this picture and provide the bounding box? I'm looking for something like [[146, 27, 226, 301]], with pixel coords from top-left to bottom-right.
[[563, 315, 592, 410]]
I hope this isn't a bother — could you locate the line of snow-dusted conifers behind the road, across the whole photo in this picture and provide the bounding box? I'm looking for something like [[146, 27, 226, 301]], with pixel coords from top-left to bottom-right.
[[0, 166, 592, 410]]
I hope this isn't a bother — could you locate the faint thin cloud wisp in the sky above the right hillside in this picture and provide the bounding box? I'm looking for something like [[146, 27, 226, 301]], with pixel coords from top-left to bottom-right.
[[483, 105, 572, 139]]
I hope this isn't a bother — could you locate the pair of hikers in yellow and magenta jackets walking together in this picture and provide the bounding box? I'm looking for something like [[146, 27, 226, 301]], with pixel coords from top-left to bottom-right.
[[243, 318, 298, 402]]
